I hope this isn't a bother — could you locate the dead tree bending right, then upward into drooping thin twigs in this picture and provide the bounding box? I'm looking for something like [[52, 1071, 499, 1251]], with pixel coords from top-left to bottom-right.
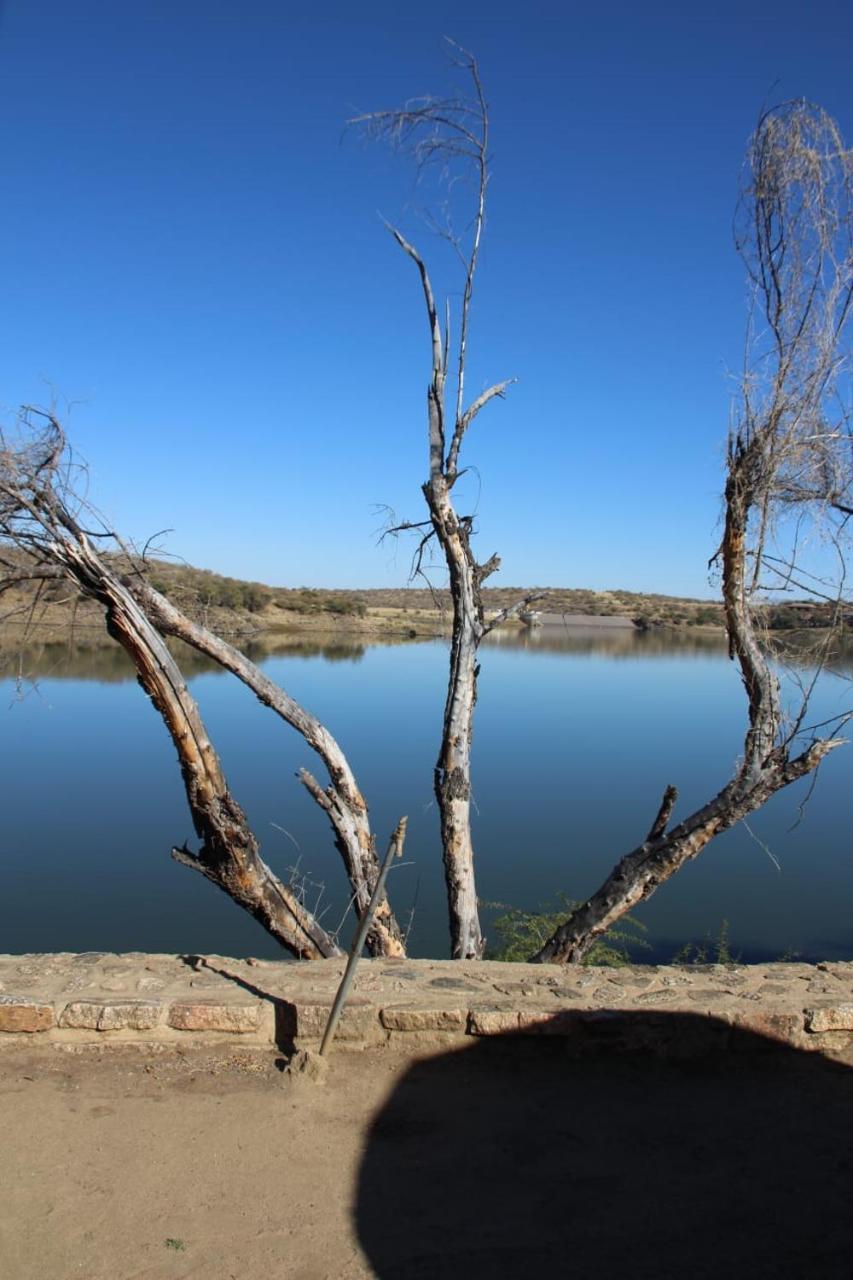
[[534, 101, 853, 961]]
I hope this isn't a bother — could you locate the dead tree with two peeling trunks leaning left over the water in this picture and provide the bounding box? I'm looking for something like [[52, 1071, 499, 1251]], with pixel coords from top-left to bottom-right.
[[0, 410, 405, 959]]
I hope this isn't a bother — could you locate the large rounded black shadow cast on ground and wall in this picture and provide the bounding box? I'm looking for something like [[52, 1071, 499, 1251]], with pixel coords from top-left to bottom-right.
[[356, 1015, 853, 1280]]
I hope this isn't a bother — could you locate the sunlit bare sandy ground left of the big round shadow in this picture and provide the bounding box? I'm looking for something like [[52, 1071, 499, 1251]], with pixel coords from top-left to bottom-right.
[[0, 1052, 379, 1280]]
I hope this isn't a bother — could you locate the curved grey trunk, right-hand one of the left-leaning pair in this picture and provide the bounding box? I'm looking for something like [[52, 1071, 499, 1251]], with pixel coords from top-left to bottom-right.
[[124, 575, 406, 956]]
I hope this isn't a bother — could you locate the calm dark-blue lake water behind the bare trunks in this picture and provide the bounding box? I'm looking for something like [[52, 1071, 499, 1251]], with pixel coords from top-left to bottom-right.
[[0, 632, 853, 959]]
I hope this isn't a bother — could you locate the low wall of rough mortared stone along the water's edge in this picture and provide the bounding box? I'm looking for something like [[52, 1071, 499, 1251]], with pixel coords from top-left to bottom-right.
[[0, 952, 853, 1061]]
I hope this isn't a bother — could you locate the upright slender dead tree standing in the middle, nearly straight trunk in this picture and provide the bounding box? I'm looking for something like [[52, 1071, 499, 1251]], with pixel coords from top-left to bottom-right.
[[350, 45, 538, 959]]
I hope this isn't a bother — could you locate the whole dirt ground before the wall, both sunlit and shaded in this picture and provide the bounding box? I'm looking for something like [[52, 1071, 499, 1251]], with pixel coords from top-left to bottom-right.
[[0, 1041, 853, 1280]]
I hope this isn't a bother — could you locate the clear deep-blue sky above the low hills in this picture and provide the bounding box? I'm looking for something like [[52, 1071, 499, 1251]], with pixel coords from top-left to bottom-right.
[[0, 0, 853, 595]]
